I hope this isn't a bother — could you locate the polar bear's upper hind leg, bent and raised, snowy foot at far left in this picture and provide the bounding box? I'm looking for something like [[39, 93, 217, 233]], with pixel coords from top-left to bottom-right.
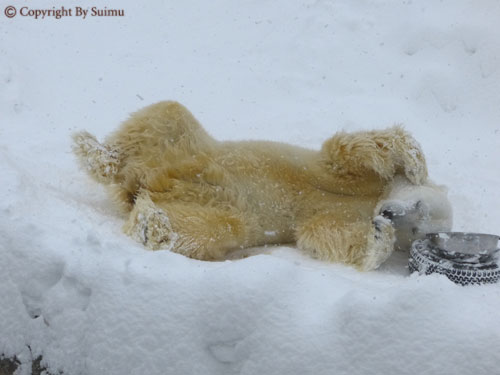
[[73, 101, 216, 211]]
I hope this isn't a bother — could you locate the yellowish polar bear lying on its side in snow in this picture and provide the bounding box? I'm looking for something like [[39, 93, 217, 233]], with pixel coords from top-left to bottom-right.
[[73, 101, 451, 271]]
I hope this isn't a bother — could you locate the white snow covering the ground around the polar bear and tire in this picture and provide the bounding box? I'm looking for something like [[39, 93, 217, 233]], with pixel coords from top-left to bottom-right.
[[0, 0, 500, 375]]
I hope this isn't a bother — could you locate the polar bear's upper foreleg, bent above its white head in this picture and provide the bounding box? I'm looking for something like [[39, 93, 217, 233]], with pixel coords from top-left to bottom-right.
[[321, 126, 427, 185]]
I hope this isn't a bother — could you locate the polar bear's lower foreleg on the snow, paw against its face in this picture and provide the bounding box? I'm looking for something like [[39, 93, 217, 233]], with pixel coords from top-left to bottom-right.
[[296, 214, 395, 271]]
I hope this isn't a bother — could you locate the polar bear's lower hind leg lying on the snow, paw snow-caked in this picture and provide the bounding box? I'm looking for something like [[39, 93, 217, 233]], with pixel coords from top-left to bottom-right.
[[124, 191, 257, 260]]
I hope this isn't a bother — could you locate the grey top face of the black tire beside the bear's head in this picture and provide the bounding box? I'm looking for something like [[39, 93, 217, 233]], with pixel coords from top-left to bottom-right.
[[426, 232, 500, 256]]
